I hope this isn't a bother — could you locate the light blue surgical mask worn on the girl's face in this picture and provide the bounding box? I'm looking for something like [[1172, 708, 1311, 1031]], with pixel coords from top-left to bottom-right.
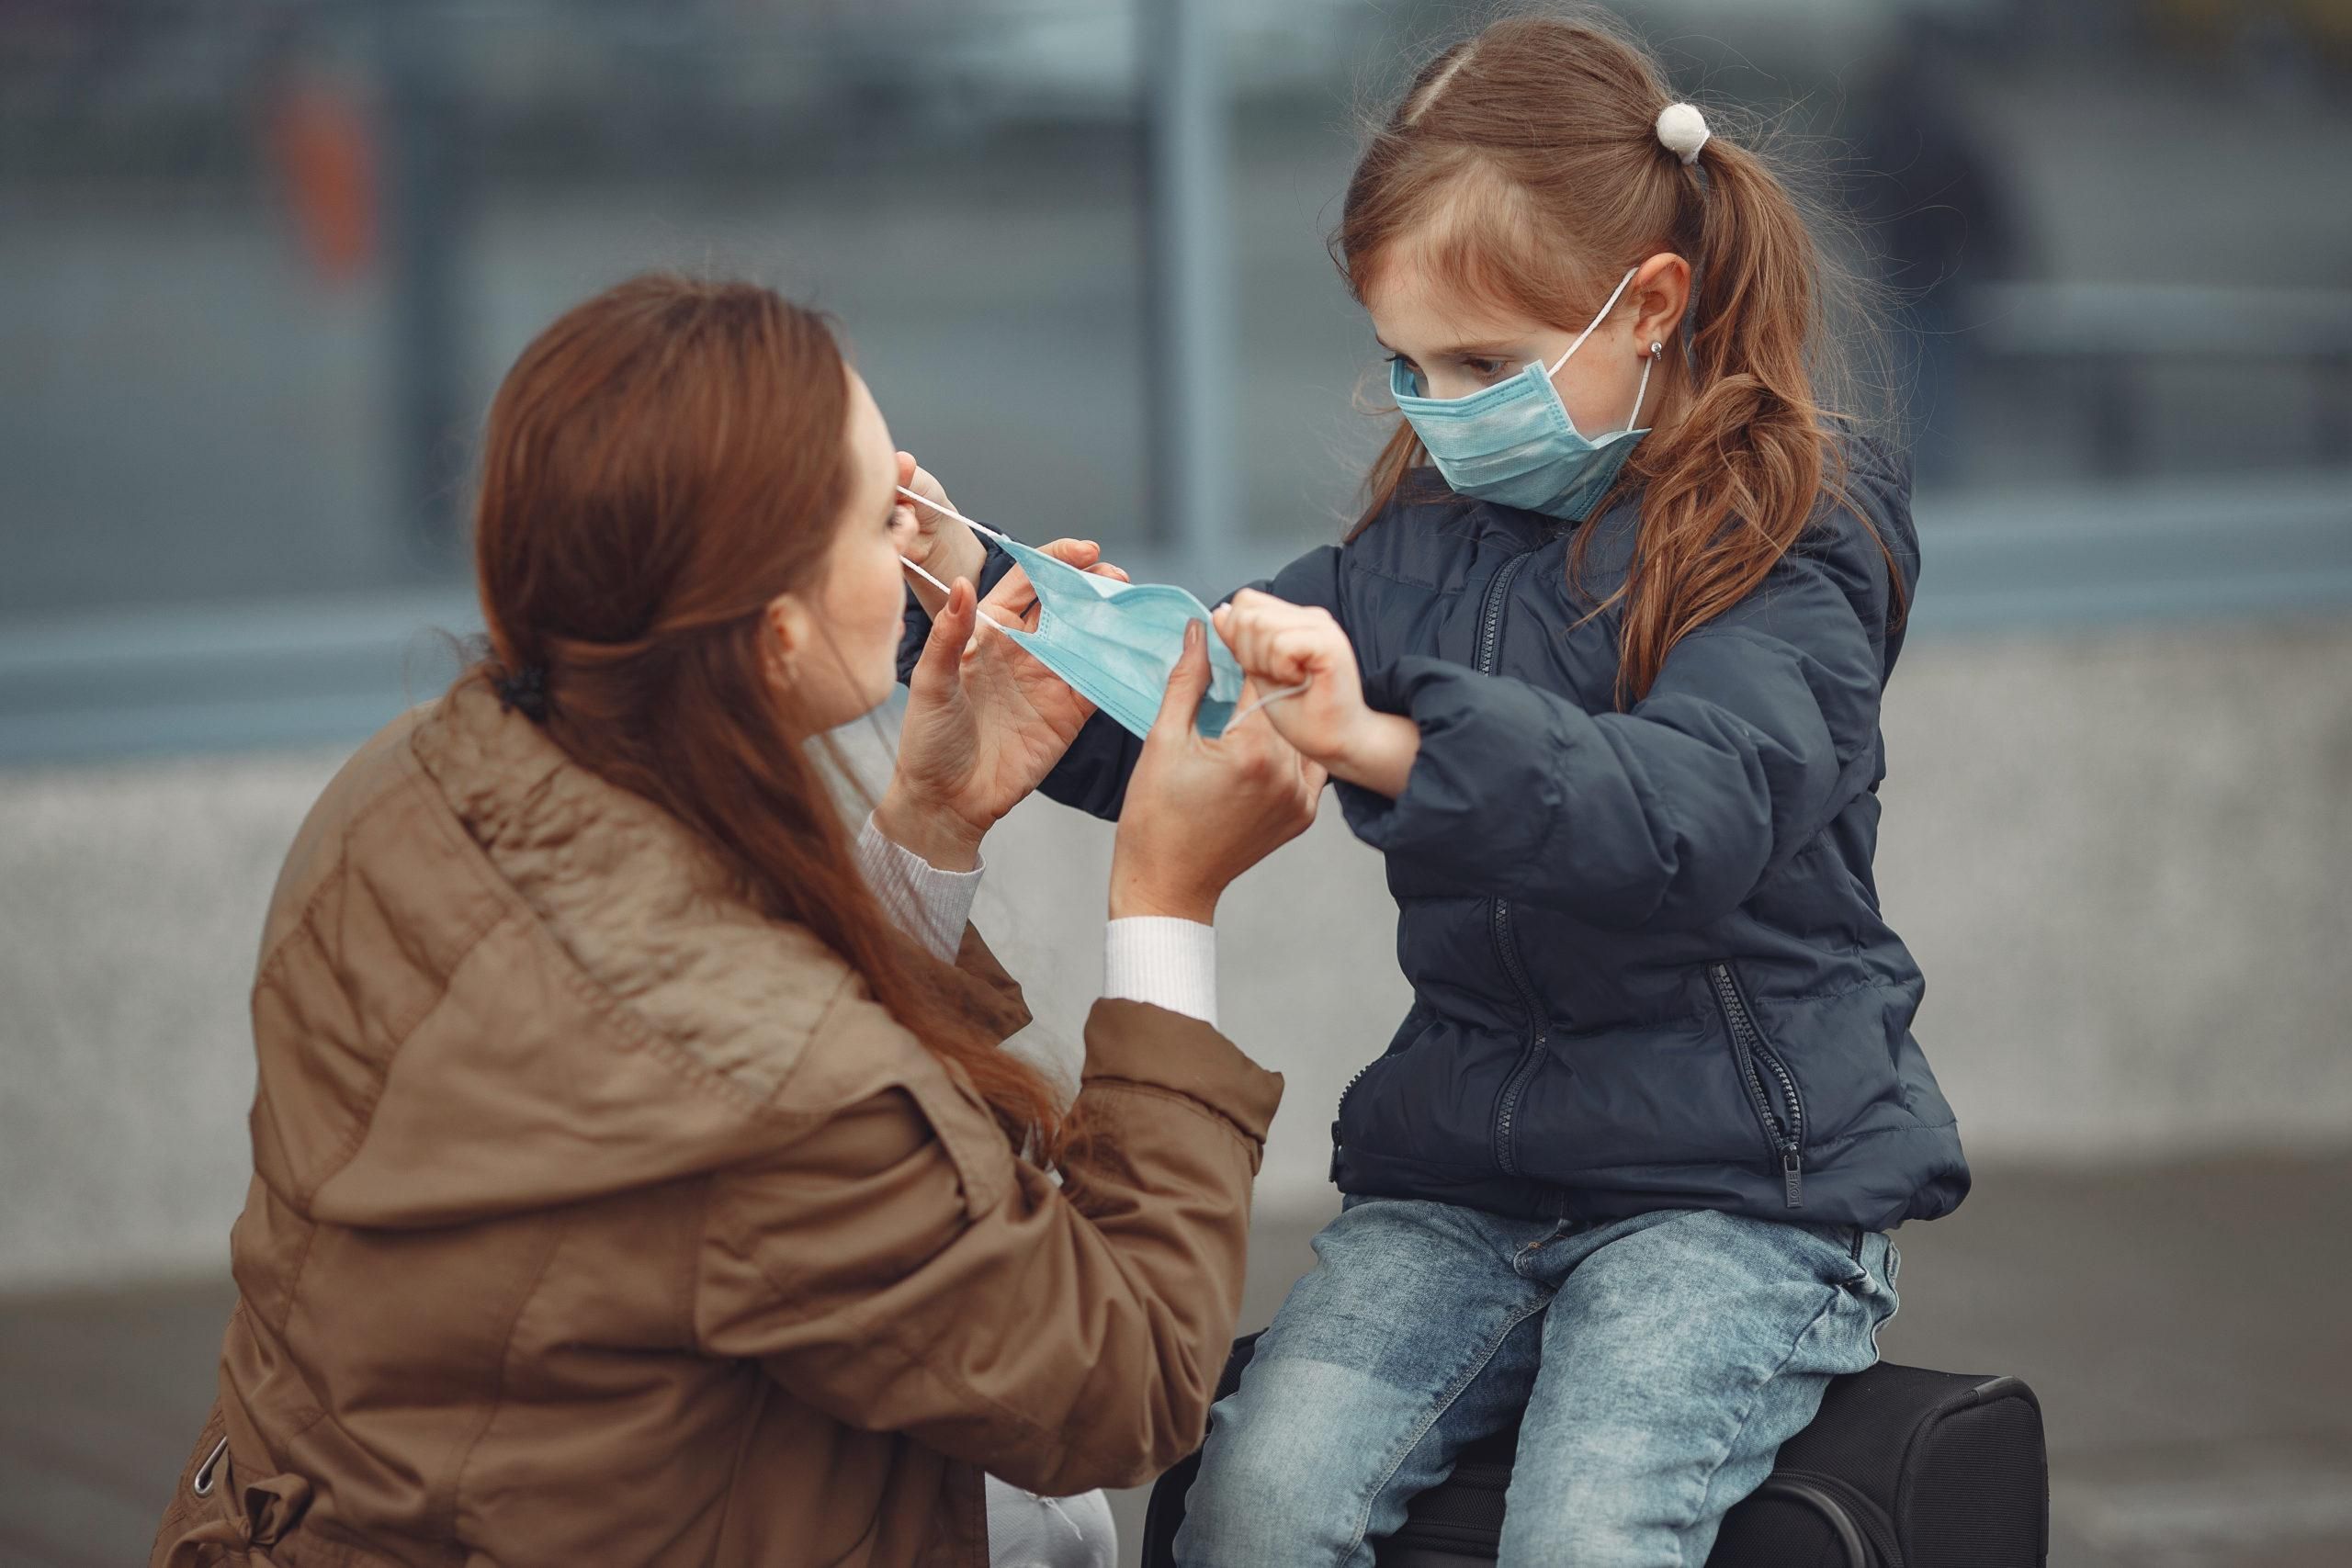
[[1387, 268, 1658, 522]]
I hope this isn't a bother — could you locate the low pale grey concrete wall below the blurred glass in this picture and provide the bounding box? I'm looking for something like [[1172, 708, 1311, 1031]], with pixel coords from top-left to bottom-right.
[[0, 621, 2352, 1291]]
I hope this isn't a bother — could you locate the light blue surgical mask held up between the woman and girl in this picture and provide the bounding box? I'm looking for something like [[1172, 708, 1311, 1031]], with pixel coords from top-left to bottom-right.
[[900, 487, 1242, 740]]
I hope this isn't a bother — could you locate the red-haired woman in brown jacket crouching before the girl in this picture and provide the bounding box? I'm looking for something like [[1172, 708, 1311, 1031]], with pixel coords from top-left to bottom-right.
[[155, 277, 1322, 1568]]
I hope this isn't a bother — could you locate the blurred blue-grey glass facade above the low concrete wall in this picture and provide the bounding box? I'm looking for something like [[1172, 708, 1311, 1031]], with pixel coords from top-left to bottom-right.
[[0, 0, 2352, 761]]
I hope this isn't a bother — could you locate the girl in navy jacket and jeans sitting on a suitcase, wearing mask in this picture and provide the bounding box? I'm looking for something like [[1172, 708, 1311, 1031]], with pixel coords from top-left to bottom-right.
[[898, 18, 1969, 1568]]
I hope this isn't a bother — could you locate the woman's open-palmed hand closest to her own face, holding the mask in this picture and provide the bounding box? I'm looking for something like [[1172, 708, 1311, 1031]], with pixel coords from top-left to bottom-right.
[[875, 538, 1126, 870]]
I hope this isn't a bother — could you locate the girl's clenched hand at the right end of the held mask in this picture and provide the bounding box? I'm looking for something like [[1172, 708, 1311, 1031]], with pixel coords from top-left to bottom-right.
[[1216, 588, 1420, 795]]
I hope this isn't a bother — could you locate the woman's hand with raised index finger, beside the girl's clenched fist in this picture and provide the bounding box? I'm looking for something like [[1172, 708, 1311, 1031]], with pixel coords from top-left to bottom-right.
[[1110, 621, 1324, 926]]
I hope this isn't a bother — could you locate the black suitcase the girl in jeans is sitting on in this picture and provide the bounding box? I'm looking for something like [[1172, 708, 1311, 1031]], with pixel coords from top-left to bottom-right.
[[1143, 1336, 2049, 1568]]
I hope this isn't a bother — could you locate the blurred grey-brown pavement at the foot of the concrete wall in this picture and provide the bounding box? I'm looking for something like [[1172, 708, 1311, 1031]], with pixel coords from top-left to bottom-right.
[[0, 1152, 2352, 1568]]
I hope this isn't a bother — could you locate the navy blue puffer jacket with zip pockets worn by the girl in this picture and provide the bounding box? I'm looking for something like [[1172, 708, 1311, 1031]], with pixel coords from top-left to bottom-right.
[[908, 449, 1969, 1229]]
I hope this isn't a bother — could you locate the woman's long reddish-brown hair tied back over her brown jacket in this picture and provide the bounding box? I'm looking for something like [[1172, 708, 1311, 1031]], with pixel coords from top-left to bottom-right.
[[463, 275, 1063, 1159]]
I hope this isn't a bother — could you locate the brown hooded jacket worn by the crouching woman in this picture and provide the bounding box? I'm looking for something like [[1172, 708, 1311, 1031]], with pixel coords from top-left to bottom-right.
[[153, 686, 1282, 1568]]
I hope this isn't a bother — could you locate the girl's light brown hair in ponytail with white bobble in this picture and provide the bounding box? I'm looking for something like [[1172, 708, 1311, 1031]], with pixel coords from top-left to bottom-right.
[[1331, 9, 1900, 703]]
